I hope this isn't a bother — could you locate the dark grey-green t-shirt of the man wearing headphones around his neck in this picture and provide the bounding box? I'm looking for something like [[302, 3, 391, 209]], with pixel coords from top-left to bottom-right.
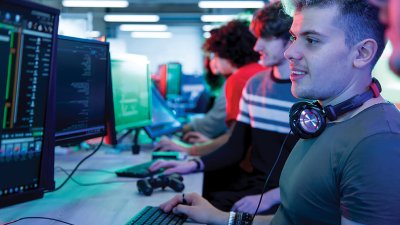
[[271, 103, 400, 225]]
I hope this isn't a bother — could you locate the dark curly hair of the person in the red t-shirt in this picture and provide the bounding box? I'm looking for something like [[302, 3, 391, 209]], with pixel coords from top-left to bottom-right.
[[203, 20, 260, 67]]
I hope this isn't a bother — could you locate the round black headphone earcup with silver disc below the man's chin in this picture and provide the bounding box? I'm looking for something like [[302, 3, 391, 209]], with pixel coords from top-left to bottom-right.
[[289, 102, 326, 139]]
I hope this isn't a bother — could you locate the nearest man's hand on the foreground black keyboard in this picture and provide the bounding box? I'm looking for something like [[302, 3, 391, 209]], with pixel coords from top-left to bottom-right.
[[160, 193, 229, 225]]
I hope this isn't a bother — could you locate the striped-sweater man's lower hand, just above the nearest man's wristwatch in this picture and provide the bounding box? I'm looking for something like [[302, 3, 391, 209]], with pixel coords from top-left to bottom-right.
[[232, 188, 280, 214]]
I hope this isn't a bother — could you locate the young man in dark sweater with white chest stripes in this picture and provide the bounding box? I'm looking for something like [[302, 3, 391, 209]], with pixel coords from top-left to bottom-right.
[[154, 3, 297, 213]]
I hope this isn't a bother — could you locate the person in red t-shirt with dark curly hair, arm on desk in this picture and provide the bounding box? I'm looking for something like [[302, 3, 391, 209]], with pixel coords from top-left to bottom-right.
[[155, 20, 265, 155]]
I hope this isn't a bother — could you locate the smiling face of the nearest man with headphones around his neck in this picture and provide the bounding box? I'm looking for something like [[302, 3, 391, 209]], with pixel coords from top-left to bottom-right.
[[285, 6, 352, 101]]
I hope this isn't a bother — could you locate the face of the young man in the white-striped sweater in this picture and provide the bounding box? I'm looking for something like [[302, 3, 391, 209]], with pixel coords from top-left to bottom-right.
[[254, 37, 288, 66]]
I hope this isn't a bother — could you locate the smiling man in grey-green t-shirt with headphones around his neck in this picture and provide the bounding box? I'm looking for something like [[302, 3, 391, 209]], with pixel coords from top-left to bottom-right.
[[155, 0, 400, 225]]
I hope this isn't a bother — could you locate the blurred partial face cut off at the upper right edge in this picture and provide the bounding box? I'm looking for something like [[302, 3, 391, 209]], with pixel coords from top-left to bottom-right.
[[369, 0, 400, 75]]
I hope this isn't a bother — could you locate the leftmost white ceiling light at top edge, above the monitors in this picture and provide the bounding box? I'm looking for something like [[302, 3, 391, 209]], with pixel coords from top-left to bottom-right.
[[62, 0, 129, 8]]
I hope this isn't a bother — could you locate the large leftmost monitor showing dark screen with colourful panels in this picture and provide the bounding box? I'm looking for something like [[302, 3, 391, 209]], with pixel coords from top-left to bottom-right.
[[0, 0, 59, 207]]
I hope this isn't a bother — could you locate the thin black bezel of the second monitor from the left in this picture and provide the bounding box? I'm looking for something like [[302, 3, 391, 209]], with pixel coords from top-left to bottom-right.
[[55, 35, 110, 146]]
